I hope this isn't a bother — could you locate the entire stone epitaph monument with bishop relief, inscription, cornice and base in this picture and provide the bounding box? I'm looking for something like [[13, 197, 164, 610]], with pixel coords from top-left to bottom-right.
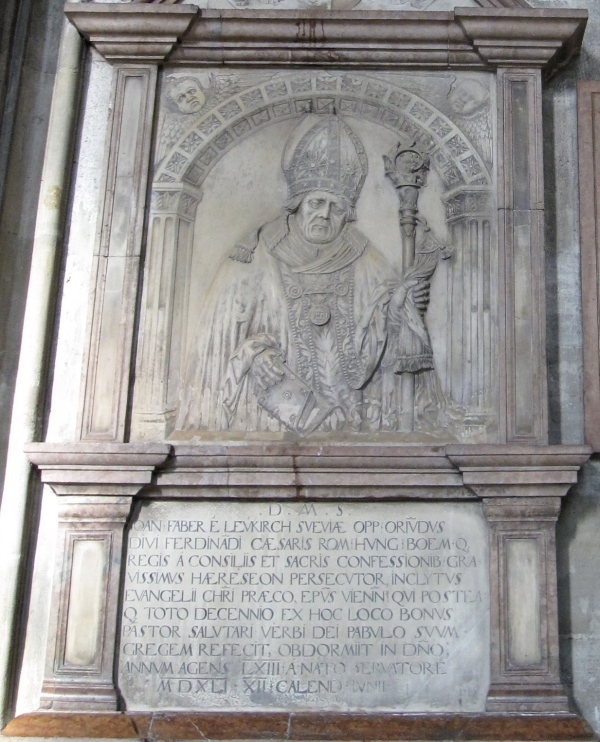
[[7, 0, 600, 740]]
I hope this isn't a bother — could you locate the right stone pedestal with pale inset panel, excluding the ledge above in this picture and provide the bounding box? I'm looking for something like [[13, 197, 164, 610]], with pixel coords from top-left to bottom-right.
[[484, 497, 569, 713]]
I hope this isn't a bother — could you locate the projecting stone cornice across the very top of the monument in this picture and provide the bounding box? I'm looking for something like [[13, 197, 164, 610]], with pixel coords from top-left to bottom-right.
[[66, 3, 587, 73]]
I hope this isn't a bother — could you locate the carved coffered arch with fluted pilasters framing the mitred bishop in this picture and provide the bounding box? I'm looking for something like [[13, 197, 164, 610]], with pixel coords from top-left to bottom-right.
[[132, 71, 493, 440]]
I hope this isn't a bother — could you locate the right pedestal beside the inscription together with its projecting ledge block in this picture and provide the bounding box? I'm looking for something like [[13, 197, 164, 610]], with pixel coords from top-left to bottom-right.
[[448, 446, 584, 713]]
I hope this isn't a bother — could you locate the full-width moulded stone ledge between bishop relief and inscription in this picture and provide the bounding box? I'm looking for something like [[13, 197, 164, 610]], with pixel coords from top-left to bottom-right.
[[26, 442, 591, 500]]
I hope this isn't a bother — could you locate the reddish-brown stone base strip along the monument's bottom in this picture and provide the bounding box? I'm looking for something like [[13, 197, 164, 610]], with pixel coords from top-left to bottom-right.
[[3, 712, 595, 742]]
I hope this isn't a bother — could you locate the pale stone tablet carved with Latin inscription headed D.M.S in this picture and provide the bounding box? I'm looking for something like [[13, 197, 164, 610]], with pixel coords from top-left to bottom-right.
[[120, 502, 489, 711]]
